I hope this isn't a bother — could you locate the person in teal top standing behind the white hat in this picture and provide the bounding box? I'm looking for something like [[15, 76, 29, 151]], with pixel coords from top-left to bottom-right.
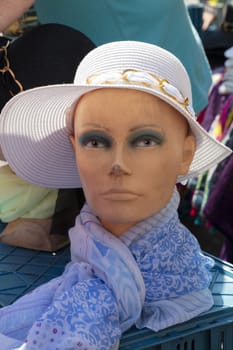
[[0, 0, 211, 113]]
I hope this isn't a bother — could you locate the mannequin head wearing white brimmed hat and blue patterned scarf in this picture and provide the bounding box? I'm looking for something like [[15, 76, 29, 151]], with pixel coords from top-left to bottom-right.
[[0, 41, 231, 350]]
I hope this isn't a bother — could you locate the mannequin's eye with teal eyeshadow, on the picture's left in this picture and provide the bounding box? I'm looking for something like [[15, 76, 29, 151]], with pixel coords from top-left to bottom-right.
[[79, 131, 112, 148]]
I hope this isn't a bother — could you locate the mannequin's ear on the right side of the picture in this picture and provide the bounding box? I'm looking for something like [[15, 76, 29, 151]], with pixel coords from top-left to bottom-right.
[[179, 135, 196, 175]]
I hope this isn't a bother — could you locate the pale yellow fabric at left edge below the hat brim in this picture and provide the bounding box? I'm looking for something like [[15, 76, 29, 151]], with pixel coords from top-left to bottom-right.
[[0, 165, 58, 222]]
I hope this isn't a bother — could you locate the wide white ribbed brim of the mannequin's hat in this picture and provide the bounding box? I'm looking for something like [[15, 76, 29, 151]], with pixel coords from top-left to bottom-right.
[[0, 84, 231, 188]]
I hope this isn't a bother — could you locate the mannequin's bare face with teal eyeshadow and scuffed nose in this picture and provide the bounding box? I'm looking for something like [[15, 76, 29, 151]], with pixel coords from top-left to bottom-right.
[[70, 89, 195, 236]]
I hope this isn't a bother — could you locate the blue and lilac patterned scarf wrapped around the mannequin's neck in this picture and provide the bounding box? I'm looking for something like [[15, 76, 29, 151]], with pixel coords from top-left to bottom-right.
[[0, 191, 213, 350]]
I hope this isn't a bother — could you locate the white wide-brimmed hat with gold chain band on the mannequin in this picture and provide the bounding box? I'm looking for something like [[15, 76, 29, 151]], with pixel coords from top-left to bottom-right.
[[0, 41, 231, 188]]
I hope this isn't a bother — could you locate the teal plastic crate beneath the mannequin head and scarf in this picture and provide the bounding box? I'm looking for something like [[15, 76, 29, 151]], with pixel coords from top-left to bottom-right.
[[0, 243, 233, 350]]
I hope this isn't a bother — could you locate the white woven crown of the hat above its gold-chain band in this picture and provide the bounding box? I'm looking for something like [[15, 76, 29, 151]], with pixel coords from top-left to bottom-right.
[[74, 41, 192, 105]]
